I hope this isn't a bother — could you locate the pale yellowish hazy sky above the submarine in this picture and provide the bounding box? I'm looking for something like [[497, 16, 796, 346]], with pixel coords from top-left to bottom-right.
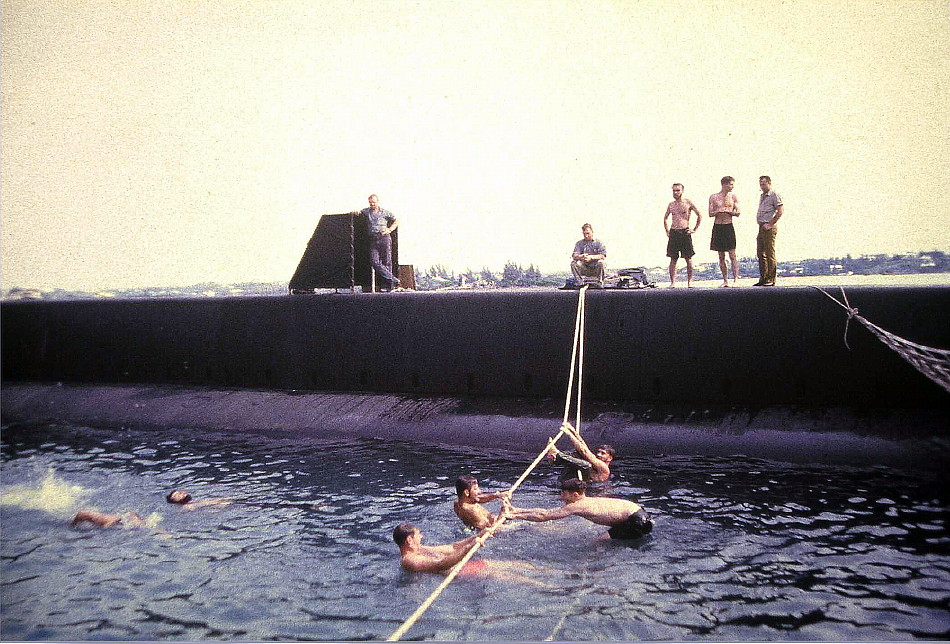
[[0, 0, 950, 289]]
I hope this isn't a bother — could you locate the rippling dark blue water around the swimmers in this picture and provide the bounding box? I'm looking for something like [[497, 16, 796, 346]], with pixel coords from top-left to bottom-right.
[[0, 425, 950, 641]]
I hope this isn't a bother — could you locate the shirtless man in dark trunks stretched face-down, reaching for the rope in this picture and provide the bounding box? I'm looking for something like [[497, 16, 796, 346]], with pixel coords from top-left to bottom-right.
[[502, 479, 653, 539]]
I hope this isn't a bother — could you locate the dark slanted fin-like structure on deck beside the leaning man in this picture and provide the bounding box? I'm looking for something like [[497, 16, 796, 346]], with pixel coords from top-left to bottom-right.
[[289, 213, 399, 293]]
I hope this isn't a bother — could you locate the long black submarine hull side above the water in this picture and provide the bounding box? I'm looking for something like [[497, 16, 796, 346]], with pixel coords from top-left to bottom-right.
[[2, 287, 950, 464]]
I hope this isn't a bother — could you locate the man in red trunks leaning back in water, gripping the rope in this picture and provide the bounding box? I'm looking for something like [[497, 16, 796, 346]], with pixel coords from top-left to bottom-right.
[[393, 523, 551, 588]]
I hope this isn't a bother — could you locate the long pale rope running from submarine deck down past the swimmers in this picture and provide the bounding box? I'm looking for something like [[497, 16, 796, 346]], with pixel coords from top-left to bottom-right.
[[386, 286, 587, 642]]
